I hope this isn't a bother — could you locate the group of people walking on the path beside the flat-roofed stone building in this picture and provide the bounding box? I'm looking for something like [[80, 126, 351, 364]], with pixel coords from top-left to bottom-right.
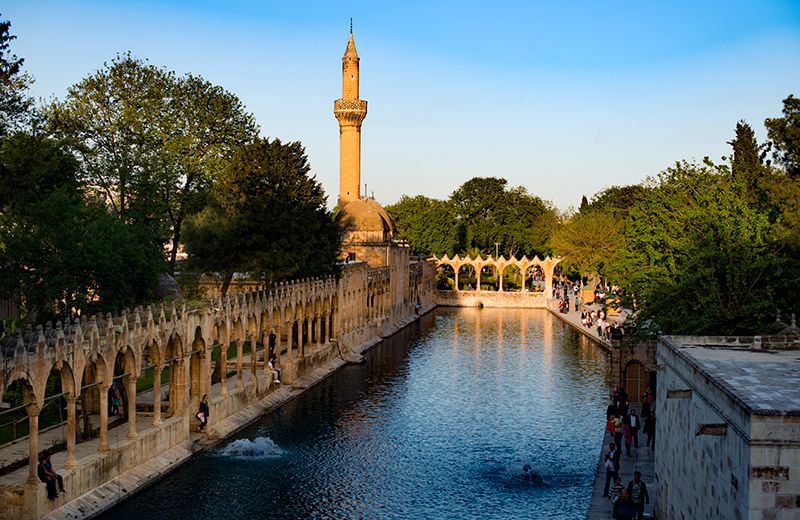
[[603, 387, 655, 520]]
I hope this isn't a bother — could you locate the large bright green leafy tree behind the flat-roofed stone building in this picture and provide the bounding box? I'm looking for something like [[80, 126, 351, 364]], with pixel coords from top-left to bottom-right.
[[625, 159, 784, 334]]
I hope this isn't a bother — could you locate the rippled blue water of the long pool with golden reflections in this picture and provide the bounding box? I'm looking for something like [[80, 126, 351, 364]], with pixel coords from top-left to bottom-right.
[[103, 309, 609, 520]]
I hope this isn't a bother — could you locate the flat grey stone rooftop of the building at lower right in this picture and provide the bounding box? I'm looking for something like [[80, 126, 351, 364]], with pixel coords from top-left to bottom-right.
[[668, 337, 800, 415]]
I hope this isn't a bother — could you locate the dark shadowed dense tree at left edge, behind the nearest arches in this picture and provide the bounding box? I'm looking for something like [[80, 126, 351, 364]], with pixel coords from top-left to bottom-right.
[[0, 133, 162, 319]]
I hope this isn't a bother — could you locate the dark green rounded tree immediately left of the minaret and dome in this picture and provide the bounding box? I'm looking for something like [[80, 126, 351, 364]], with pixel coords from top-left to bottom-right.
[[184, 138, 340, 294]]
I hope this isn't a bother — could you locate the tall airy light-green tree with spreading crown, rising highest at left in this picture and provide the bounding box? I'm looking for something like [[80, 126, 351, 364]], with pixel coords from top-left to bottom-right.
[[47, 53, 258, 272]]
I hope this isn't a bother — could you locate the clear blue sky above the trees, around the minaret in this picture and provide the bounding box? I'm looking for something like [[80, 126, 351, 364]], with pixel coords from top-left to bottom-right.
[[0, 0, 800, 210]]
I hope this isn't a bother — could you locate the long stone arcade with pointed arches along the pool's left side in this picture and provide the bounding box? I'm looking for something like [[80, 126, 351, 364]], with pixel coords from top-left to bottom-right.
[[0, 259, 435, 518]]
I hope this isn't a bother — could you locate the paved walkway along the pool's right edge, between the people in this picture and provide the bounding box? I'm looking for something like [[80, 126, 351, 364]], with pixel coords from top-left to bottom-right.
[[553, 305, 655, 520]]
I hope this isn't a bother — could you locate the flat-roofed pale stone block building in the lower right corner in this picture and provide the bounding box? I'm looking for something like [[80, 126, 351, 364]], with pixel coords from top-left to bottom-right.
[[654, 336, 800, 520]]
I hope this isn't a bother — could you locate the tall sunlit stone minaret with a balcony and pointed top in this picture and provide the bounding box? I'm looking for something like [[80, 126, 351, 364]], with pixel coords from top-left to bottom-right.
[[333, 20, 367, 211]]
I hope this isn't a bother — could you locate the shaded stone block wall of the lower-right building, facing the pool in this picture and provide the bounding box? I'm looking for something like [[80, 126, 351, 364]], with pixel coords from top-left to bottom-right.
[[654, 338, 761, 520]]
